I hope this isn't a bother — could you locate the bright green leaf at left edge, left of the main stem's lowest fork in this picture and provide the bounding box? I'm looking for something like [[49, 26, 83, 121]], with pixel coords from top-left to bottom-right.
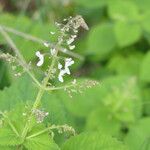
[[0, 127, 23, 146]]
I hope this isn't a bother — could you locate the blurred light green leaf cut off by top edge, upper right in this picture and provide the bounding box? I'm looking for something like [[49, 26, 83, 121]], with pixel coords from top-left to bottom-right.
[[108, 0, 139, 21]]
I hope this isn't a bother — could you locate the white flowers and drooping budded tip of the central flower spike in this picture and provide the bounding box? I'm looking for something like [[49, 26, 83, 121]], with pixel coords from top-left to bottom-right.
[[36, 16, 88, 82]]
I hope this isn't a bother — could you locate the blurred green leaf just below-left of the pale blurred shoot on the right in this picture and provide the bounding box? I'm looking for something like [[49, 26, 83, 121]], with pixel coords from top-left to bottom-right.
[[86, 106, 121, 135]]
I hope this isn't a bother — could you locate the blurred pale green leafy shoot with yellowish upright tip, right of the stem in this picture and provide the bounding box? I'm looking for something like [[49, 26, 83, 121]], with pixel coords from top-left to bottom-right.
[[103, 77, 142, 123]]
